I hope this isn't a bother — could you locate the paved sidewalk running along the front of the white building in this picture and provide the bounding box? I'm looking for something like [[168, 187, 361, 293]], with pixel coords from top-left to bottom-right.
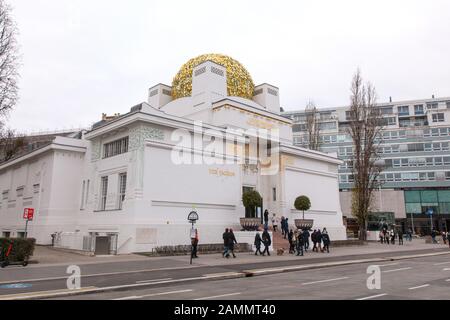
[[32, 239, 450, 267]]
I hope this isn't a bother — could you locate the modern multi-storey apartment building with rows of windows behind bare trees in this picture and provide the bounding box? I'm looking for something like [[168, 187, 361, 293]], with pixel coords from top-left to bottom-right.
[[283, 96, 450, 233]]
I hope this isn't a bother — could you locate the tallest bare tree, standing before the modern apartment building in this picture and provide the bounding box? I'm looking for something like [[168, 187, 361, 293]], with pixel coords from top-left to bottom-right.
[[348, 70, 382, 240]]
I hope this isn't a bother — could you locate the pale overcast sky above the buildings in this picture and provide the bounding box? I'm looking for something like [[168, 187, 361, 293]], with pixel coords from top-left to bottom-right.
[[9, 0, 450, 131]]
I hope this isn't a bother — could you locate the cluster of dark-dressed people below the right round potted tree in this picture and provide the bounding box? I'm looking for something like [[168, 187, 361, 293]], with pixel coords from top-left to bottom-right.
[[287, 228, 331, 256]]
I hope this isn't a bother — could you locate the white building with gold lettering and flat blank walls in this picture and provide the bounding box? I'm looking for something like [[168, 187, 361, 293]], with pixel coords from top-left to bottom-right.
[[0, 55, 346, 254]]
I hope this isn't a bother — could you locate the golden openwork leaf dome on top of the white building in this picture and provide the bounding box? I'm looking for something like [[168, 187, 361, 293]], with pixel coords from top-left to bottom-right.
[[172, 53, 255, 100]]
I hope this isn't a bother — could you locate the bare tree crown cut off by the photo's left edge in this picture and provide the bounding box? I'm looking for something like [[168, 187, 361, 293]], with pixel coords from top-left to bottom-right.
[[0, 0, 19, 116]]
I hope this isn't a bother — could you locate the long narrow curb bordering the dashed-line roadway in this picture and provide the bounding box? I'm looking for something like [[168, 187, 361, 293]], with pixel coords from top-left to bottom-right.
[[6, 251, 450, 300]]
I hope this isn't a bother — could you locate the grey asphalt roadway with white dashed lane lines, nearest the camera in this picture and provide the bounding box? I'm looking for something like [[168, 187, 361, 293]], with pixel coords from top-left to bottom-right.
[[54, 255, 450, 301]]
